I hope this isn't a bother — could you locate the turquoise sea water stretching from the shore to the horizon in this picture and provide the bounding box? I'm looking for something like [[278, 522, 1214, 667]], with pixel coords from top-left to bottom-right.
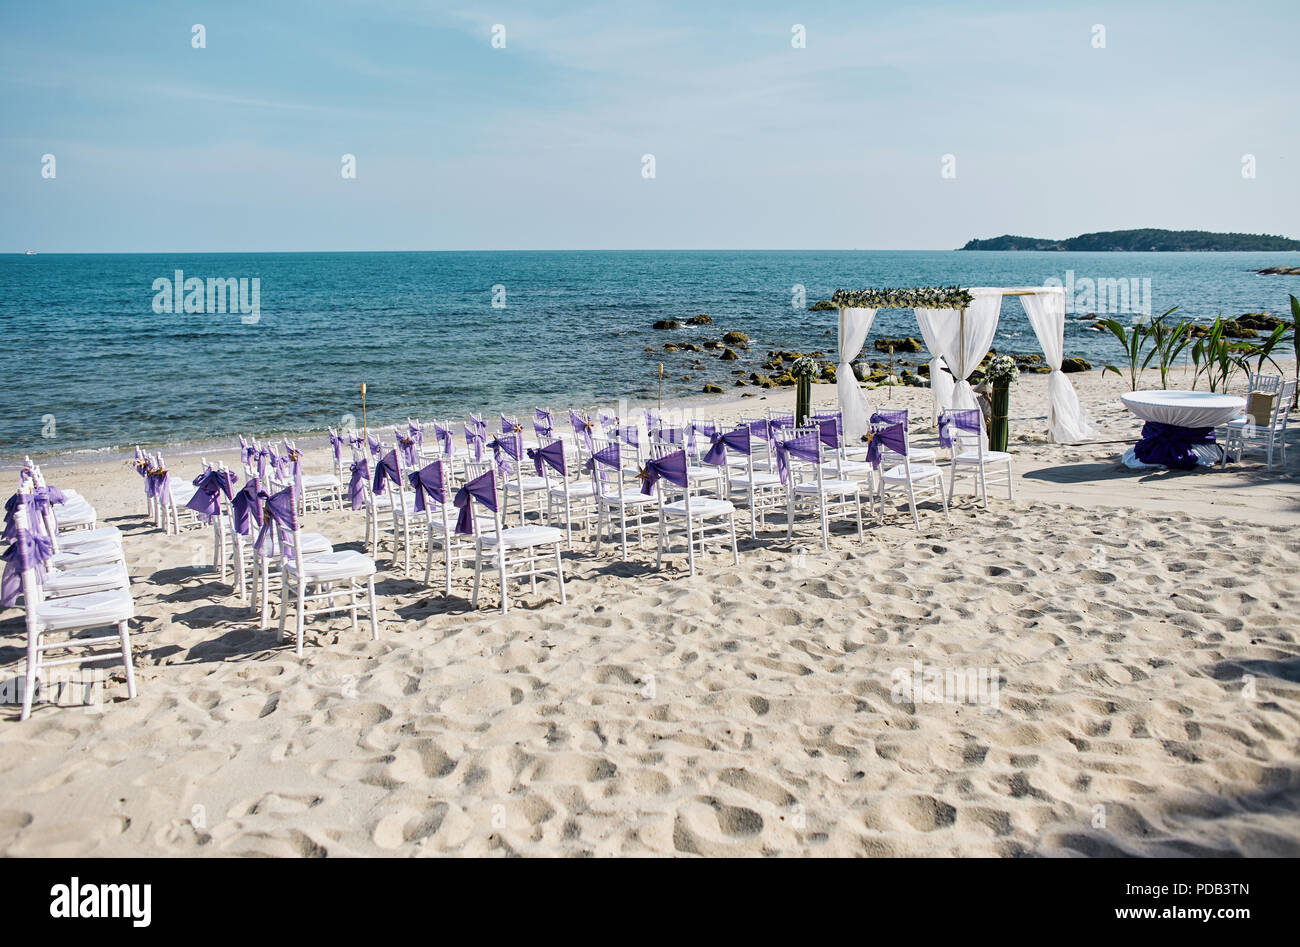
[[0, 251, 1300, 458]]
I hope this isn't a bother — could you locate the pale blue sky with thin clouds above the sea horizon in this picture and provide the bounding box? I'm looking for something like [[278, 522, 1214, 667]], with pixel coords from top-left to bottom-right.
[[0, 0, 1300, 252]]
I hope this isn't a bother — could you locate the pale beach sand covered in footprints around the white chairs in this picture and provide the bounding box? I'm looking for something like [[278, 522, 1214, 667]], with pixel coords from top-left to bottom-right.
[[0, 371, 1300, 857]]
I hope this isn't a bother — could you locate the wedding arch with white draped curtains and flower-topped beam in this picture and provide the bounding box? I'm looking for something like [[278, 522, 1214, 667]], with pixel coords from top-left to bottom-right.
[[831, 286, 1096, 444]]
